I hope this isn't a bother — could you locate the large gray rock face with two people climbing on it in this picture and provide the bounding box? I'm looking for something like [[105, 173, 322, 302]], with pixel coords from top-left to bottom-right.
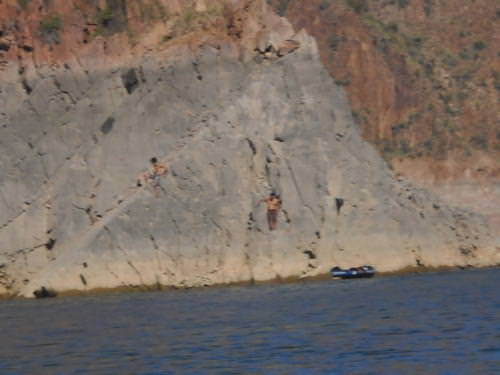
[[0, 34, 500, 297]]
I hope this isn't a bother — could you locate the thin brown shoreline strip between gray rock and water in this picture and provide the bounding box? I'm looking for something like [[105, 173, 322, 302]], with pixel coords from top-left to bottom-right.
[[0, 264, 500, 302]]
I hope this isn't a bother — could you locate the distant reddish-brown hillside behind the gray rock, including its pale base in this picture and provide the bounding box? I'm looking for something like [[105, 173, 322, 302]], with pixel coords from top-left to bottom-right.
[[270, 0, 500, 232]]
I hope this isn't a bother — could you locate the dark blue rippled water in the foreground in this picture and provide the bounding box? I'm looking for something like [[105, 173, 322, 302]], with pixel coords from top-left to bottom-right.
[[0, 269, 500, 375]]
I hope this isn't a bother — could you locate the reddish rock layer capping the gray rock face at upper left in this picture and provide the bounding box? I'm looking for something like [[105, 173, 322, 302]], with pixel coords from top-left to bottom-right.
[[0, 0, 298, 77]]
